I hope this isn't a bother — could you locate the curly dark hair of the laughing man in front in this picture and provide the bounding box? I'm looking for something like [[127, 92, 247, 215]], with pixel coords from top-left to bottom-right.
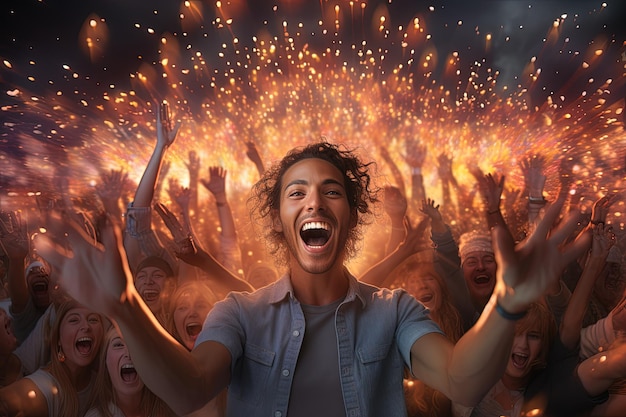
[[248, 141, 379, 265]]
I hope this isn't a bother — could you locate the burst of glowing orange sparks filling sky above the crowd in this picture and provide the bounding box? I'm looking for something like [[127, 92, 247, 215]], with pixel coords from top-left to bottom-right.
[[0, 0, 626, 272]]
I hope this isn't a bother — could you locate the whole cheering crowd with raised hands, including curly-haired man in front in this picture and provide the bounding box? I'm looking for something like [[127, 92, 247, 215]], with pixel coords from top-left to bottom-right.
[[0, 101, 626, 417]]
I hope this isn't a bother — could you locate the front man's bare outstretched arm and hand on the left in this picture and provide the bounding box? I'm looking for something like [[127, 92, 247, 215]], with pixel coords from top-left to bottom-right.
[[36, 216, 231, 415]]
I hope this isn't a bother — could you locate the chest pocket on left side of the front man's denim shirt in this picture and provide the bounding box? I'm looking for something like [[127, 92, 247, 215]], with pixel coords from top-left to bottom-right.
[[228, 343, 276, 405]]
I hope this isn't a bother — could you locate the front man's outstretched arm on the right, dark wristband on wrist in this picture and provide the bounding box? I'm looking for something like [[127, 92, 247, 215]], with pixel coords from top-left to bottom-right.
[[411, 171, 575, 406]]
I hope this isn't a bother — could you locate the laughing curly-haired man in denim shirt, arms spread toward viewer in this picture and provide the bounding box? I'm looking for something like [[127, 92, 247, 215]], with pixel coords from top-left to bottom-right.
[[39, 141, 573, 417]]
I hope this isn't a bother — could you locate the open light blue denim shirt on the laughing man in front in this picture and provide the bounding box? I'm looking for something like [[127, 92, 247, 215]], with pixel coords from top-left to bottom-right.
[[196, 272, 441, 417]]
